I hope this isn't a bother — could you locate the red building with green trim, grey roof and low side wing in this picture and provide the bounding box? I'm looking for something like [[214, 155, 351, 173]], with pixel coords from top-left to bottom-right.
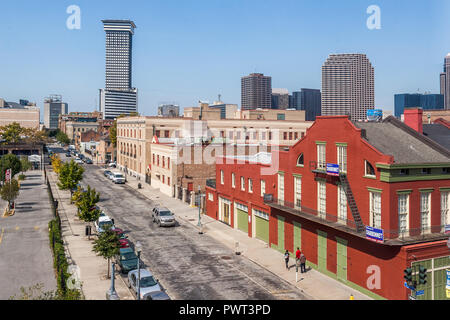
[[207, 116, 450, 300]]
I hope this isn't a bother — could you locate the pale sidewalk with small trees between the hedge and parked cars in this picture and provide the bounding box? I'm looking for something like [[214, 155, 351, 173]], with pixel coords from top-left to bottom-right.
[[47, 171, 134, 300]]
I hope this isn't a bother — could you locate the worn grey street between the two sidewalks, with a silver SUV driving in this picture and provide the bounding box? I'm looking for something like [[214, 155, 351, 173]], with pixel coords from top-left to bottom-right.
[[76, 161, 306, 300]]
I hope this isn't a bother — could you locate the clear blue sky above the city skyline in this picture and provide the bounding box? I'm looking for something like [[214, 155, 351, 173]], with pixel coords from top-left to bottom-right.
[[0, 0, 450, 115]]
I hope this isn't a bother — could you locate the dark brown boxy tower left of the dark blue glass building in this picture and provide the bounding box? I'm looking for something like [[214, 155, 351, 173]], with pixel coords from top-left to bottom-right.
[[241, 73, 272, 110]]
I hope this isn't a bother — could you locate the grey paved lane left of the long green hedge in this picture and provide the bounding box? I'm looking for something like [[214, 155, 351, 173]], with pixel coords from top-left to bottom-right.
[[0, 171, 56, 300]]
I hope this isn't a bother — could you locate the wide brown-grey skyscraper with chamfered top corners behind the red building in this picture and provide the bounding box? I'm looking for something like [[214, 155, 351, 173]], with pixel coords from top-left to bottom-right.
[[322, 54, 375, 120]]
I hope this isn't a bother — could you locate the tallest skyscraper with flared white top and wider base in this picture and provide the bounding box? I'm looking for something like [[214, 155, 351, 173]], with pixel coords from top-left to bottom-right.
[[100, 20, 137, 119]]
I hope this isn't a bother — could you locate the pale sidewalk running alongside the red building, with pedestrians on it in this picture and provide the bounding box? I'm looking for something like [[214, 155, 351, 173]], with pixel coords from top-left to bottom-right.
[[127, 172, 372, 300]]
